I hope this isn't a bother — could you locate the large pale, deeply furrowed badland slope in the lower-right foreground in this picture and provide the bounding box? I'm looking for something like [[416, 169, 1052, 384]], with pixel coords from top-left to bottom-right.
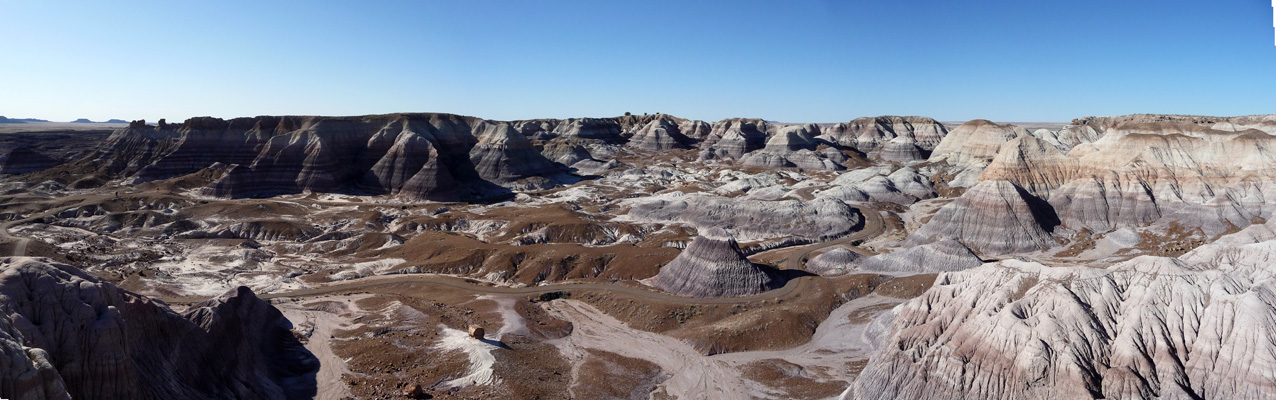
[[842, 229, 1276, 399]]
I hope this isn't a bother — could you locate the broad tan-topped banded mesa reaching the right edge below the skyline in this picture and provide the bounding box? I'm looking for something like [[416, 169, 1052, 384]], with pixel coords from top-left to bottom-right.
[[959, 115, 1276, 236]]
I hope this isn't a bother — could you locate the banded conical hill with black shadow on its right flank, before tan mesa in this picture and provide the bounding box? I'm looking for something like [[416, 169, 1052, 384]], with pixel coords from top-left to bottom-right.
[[907, 180, 1059, 254]]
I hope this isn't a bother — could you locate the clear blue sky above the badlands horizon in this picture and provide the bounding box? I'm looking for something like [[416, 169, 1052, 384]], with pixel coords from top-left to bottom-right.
[[0, 0, 1276, 121]]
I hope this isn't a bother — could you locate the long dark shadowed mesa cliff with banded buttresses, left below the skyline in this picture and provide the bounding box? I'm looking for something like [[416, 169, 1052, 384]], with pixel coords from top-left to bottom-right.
[[74, 114, 574, 199]]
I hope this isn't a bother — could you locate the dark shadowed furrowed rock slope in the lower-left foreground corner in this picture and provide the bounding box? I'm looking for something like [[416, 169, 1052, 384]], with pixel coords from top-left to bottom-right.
[[0, 257, 319, 399]]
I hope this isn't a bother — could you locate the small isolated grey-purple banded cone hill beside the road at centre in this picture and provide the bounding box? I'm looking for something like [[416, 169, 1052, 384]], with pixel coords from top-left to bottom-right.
[[652, 229, 783, 298]]
